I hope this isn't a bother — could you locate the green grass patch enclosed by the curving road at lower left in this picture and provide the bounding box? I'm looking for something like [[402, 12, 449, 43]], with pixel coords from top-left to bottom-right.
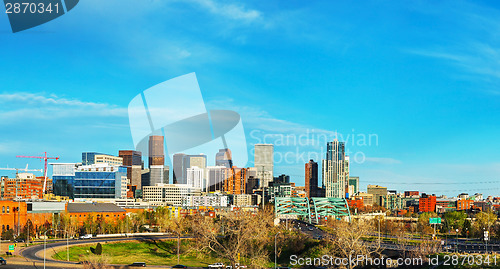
[[52, 240, 217, 267]]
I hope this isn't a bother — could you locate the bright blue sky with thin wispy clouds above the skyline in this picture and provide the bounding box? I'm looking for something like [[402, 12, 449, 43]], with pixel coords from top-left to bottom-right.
[[0, 0, 500, 196]]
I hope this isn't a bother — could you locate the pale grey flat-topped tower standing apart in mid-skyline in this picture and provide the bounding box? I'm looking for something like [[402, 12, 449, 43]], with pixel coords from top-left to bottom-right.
[[254, 144, 274, 188]]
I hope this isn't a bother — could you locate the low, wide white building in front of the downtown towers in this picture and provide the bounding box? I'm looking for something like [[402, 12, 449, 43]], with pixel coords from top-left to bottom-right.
[[142, 184, 201, 206]]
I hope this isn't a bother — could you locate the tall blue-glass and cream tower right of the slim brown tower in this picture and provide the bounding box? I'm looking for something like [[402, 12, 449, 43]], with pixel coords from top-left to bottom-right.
[[322, 139, 346, 198]]
